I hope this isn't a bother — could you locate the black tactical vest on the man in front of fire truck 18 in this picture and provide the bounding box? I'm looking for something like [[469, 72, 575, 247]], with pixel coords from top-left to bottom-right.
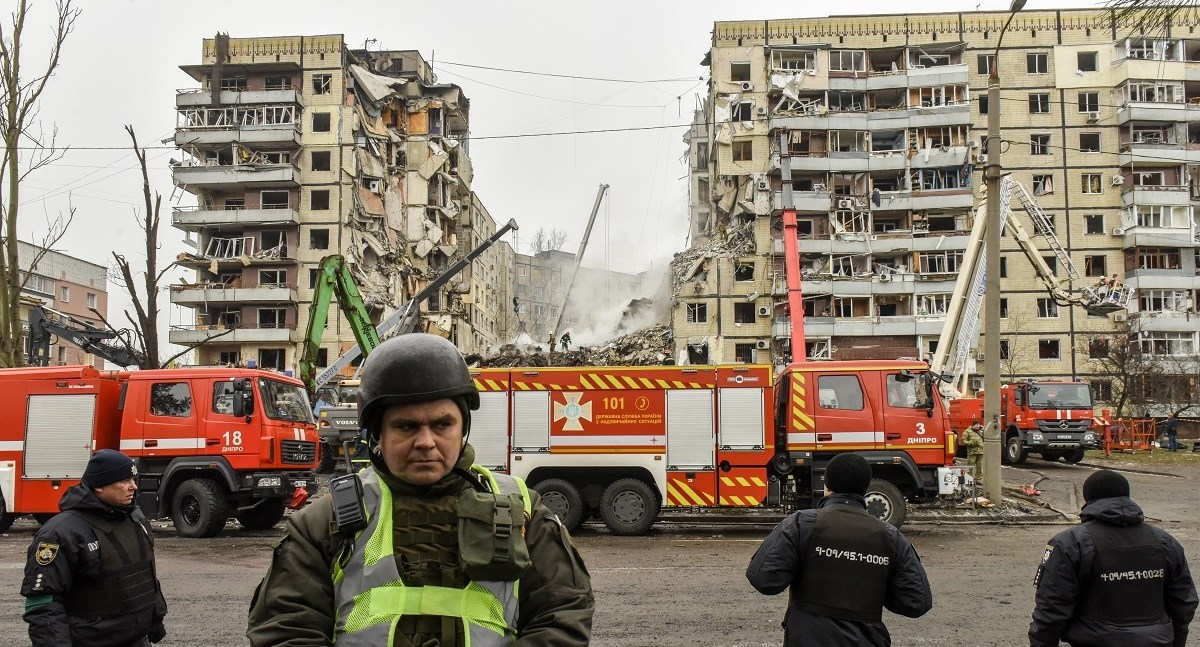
[[62, 510, 158, 616]]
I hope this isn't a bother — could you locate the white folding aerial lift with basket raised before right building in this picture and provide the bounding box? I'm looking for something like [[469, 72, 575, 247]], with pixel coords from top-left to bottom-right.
[[930, 175, 1130, 396]]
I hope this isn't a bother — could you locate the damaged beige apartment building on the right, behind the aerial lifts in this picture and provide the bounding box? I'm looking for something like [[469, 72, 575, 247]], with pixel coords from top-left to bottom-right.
[[672, 8, 1200, 388]]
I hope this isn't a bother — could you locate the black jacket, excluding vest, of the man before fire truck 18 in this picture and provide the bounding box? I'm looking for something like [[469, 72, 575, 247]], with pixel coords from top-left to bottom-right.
[[20, 485, 167, 647]]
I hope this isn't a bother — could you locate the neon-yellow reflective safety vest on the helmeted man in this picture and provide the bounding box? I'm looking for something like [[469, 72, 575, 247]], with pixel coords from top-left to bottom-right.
[[334, 465, 532, 647]]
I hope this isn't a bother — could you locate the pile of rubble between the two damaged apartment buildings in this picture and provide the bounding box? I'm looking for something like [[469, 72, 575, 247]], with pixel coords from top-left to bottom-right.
[[480, 325, 673, 369]]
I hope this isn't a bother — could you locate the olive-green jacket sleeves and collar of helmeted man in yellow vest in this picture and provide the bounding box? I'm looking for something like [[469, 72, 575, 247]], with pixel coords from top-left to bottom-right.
[[246, 445, 595, 647]]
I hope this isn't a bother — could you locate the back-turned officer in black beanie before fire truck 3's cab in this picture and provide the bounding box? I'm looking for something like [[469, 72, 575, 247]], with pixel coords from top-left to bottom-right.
[[746, 454, 934, 647]]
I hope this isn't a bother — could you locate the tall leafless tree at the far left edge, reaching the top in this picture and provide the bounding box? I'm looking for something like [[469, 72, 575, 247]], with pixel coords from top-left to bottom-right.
[[0, 0, 79, 366]]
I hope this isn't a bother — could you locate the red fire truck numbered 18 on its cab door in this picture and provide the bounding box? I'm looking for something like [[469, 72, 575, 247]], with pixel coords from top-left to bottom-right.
[[0, 366, 317, 537]]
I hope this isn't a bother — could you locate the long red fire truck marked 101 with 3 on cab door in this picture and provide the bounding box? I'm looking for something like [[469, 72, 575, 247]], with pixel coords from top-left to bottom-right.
[[470, 360, 961, 535]]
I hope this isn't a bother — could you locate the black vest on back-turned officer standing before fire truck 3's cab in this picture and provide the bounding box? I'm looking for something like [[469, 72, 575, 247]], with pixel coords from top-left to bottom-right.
[[792, 505, 895, 622]]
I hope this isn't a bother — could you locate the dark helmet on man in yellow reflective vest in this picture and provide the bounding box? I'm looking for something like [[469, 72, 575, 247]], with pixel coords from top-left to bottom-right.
[[359, 333, 479, 432]]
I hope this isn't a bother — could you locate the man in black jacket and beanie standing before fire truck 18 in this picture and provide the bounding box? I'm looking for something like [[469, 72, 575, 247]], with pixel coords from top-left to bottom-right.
[[20, 449, 167, 647]]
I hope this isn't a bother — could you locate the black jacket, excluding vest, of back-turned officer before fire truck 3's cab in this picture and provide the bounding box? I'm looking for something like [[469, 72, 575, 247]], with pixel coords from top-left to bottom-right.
[[746, 495, 934, 647]]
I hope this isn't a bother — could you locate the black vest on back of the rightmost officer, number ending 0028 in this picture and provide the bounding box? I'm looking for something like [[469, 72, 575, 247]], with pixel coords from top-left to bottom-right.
[[1078, 521, 1166, 627]]
